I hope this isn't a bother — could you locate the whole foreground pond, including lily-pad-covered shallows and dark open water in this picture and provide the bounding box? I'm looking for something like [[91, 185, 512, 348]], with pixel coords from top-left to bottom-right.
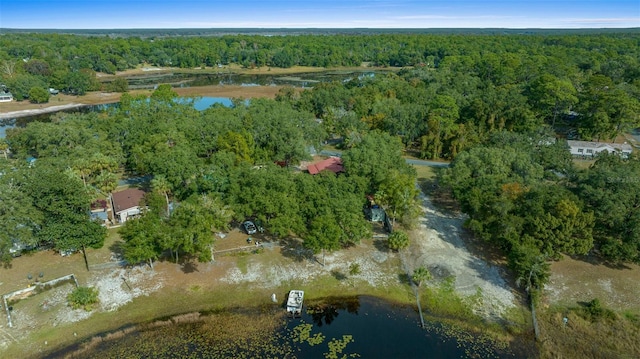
[[47, 296, 531, 359]]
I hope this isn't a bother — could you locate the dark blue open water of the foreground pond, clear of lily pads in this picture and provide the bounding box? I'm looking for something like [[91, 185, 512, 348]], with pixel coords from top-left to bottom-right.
[[287, 296, 513, 359]]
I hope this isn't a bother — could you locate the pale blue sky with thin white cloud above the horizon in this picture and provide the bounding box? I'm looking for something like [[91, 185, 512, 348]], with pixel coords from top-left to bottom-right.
[[0, 0, 640, 29]]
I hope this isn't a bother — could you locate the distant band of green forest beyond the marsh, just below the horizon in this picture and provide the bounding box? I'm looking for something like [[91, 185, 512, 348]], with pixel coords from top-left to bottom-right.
[[0, 31, 640, 105]]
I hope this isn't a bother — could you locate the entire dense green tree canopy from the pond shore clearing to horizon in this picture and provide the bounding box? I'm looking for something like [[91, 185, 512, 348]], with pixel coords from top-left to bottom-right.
[[0, 33, 640, 296]]
